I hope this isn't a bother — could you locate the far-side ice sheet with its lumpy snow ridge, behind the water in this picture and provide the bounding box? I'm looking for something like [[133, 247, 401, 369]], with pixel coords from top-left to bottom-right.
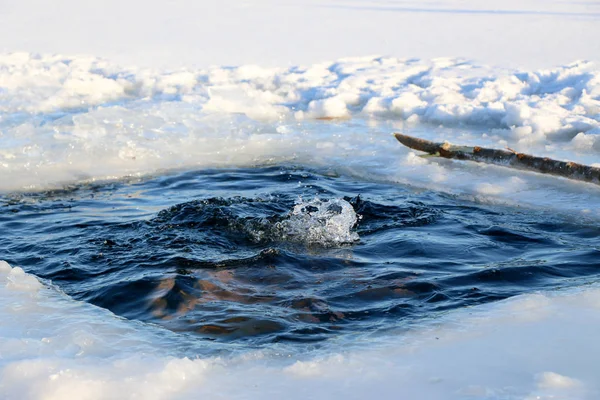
[[0, 53, 600, 215]]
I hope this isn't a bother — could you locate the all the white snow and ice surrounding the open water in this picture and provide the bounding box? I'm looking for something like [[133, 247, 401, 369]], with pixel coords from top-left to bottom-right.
[[0, 0, 600, 400]]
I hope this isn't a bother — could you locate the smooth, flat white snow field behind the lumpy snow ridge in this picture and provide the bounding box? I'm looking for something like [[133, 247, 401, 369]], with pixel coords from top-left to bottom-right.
[[0, 0, 600, 69]]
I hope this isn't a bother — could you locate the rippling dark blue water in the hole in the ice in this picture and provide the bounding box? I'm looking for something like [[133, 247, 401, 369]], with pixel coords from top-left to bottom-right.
[[0, 166, 600, 346]]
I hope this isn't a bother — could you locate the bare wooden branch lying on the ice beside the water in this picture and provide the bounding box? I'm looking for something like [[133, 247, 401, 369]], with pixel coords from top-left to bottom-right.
[[394, 133, 600, 185]]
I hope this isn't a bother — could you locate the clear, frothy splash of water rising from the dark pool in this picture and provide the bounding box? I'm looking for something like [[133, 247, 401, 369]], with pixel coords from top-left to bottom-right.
[[274, 198, 359, 247]]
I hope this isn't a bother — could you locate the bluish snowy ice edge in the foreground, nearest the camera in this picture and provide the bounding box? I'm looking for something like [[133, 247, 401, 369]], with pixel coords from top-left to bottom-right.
[[0, 261, 600, 400]]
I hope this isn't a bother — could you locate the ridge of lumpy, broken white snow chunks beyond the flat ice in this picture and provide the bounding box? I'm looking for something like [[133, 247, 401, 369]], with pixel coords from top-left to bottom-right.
[[0, 53, 600, 134]]
